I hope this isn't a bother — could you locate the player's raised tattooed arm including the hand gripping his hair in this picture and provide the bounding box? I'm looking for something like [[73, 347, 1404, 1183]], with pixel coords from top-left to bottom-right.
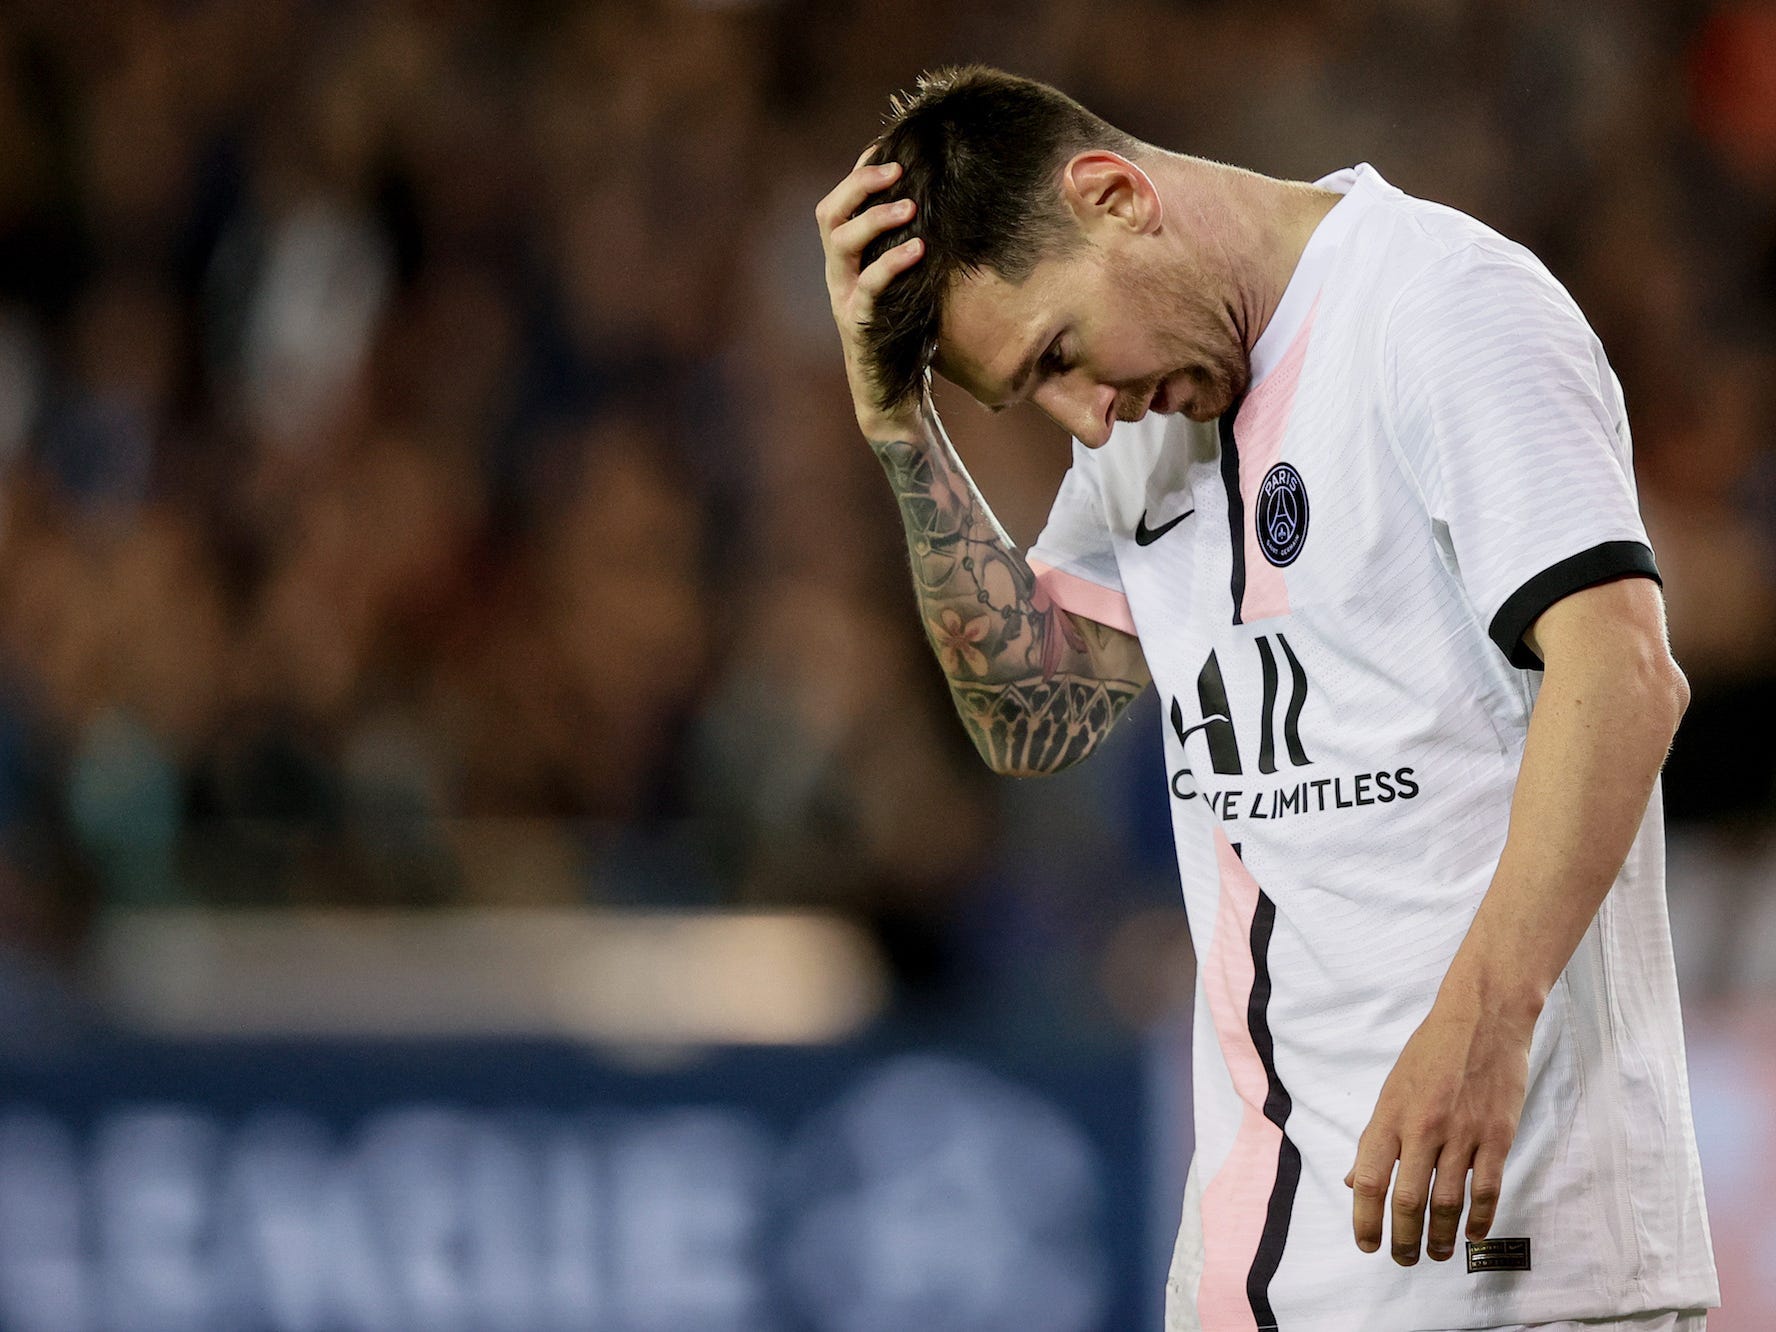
[[815, 153, 1149, 776]]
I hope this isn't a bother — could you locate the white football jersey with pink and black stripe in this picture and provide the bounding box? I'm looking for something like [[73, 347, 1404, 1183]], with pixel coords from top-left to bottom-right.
[[1030, 165, 1717, 1332]]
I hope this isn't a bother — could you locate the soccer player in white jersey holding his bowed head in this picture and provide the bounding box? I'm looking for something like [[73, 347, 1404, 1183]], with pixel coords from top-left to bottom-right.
[[817, 67, 1717, 1332]]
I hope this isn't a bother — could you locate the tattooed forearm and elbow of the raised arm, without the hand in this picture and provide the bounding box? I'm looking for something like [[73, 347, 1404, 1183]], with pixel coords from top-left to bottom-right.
[[870, 407, 1147, 776]]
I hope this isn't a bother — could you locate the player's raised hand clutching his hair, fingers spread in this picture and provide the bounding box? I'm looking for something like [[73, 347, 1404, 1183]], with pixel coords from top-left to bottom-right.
[[813, 146, 925, 440]]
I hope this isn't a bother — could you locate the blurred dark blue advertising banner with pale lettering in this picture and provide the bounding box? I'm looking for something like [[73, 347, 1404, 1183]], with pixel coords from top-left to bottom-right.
[[0, 1041, 1176, 1332]]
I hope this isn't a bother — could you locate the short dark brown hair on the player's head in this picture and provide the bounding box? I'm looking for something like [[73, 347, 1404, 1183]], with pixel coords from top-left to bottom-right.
[[858, 66, 1144, 410]]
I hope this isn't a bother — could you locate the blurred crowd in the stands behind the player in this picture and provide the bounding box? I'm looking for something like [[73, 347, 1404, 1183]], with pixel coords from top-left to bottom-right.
[[0, 0, 1776, 1015]]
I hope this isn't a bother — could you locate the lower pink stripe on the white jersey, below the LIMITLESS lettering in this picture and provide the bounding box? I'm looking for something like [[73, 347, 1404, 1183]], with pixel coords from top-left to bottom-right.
[[1197, 828, 1282, 1332]]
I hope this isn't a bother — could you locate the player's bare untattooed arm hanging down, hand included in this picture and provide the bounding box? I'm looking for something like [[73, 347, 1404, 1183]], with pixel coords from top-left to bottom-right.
[[1346, 577, 1689, 1266]]
